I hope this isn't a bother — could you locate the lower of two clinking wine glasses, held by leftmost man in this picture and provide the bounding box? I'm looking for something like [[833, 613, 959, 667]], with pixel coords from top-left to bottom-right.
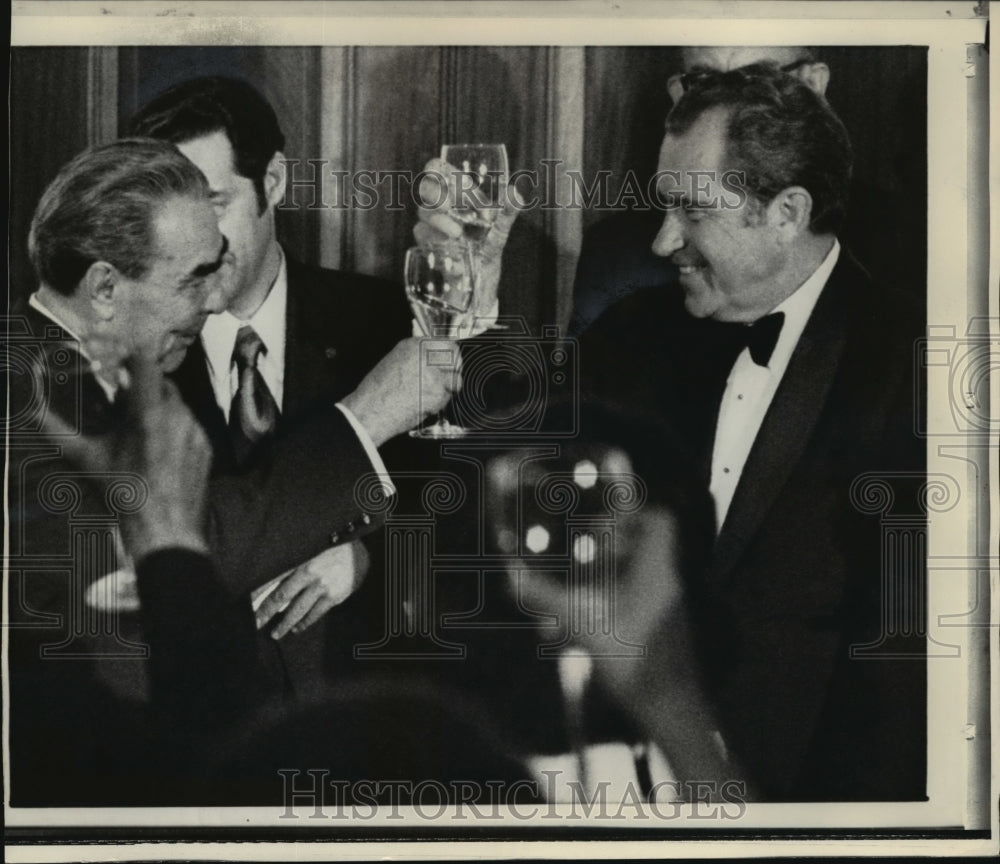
[[405, 241, 473, 438]]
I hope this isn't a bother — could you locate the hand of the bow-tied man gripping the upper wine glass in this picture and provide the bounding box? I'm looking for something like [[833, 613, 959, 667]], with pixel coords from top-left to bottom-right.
[[413, 159, 524, 317]]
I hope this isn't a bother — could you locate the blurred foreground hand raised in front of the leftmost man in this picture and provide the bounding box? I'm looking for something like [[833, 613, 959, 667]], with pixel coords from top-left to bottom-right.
[[43, 336, 212, 562]]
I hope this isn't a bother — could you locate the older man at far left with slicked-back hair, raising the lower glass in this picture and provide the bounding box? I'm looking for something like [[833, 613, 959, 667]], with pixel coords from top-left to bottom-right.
[[6, 139, 456, 806]]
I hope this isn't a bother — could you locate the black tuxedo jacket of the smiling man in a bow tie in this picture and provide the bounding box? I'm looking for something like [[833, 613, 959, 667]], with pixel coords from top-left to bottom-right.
[[581, 250, 926, 800]]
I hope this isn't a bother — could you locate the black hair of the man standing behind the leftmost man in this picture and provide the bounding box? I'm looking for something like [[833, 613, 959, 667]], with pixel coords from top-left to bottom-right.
[[129, 76, 285, 213]]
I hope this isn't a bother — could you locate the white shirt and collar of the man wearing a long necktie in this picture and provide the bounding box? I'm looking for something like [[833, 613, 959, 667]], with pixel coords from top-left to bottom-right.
[[201, 247, 288, 416]]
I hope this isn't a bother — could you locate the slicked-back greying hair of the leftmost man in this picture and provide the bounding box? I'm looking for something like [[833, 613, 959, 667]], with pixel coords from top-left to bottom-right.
[[28, 138, 208, 295]]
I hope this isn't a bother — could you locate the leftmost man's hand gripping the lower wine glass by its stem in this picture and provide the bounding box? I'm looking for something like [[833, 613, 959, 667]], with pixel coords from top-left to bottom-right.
[[341, 337, 462, 447]]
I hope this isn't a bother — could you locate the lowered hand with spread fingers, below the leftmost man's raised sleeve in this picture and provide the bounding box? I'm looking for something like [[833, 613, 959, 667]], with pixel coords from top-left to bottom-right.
[[256, 540, 371, 639]]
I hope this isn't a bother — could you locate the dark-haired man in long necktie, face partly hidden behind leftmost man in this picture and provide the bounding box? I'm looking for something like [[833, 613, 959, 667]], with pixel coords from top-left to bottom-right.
[[131, 77, 422, 693]]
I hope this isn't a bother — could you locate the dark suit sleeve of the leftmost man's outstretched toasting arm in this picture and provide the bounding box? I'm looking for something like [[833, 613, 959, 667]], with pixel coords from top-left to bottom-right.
[[209, 405, 384, 597]]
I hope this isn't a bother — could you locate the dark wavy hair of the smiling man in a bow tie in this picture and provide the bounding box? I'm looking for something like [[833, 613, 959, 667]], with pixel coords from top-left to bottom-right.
[[666, 63, 853, 234]]
